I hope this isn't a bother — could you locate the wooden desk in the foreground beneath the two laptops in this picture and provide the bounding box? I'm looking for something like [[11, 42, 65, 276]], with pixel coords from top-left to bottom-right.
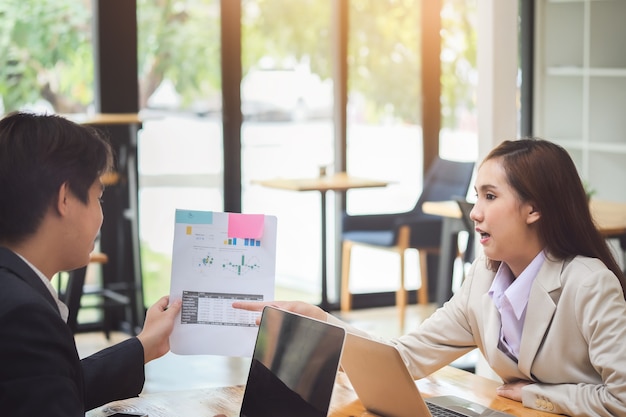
[[86, 366, 554, 417]]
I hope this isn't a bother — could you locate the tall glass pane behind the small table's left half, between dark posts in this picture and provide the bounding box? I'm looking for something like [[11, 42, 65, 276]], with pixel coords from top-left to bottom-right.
[[241, 0, 333, 303]]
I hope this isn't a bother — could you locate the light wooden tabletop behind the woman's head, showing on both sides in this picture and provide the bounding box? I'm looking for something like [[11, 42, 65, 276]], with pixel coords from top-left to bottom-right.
[[422, 200, 626, 236]]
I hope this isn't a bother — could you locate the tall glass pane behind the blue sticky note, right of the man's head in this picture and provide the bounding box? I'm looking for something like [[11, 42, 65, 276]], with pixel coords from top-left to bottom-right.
[[137, 0, 224, 305]]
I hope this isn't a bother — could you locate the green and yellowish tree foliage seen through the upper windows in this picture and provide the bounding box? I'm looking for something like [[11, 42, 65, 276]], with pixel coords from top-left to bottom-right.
[[0, 0, 476, 126]]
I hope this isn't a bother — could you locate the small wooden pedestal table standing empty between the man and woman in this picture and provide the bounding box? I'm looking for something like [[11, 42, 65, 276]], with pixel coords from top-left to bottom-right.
[[253, 172, 389, 310]]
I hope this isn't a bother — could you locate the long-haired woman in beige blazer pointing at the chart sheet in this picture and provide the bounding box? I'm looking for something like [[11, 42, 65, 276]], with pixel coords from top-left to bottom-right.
[[234, 139, 626, 416]]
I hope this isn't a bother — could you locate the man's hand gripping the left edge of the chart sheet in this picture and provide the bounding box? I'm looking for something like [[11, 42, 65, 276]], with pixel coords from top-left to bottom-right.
[[137, 296, 182, 363]]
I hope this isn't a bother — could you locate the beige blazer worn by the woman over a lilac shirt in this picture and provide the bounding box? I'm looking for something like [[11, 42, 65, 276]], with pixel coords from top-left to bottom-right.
[[330, 257, 626, 416]]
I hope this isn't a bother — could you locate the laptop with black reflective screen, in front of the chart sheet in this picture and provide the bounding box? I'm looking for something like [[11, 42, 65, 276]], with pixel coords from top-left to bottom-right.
[[239, 306, 346, 417]]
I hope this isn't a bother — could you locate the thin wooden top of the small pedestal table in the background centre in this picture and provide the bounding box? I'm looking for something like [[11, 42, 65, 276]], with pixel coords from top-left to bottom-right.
[[253, 172, 389, 191]]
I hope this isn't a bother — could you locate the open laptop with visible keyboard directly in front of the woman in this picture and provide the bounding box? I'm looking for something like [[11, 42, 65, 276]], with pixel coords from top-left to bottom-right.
[[341, 333, 512, 417]]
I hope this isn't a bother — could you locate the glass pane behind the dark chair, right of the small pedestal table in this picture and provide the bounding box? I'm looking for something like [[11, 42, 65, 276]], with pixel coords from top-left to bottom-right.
[[346, 0, 423, 293]]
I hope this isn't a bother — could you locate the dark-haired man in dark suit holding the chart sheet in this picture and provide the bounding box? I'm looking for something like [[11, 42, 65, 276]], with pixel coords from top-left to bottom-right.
[[0, 113, 180, 417]]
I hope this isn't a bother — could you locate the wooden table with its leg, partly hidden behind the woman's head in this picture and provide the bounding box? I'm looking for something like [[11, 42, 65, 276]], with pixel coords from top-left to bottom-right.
[[422, 200, 626, 305]]
